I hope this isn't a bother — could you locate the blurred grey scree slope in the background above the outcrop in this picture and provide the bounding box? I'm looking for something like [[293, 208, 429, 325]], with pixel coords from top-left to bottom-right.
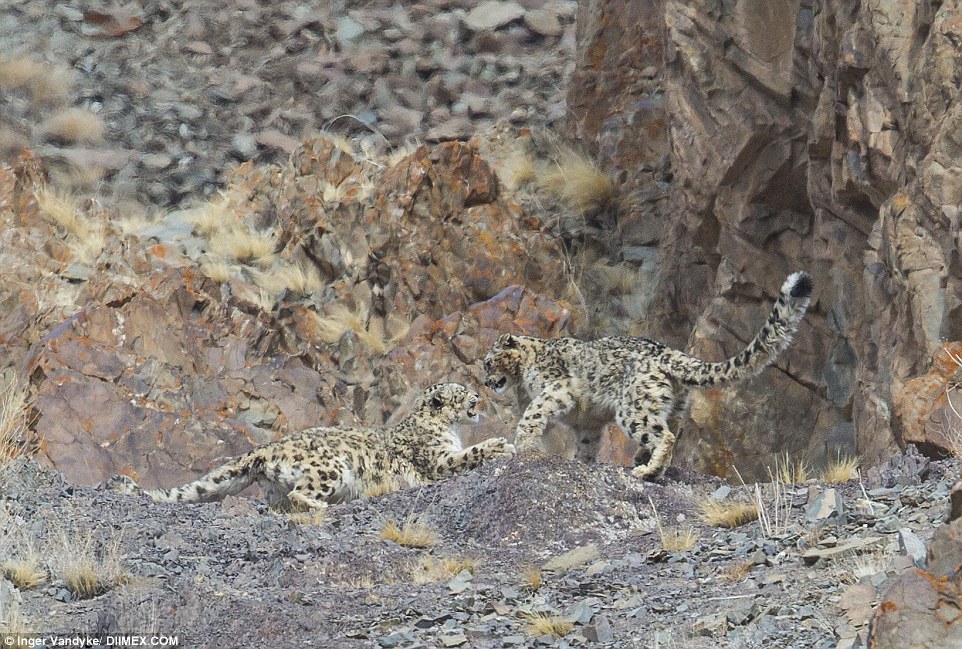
[[0, 0, 576, 208]]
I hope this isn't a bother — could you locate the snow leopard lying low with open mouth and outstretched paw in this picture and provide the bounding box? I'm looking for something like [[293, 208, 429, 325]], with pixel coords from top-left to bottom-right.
[[108, 383, 514, 509]]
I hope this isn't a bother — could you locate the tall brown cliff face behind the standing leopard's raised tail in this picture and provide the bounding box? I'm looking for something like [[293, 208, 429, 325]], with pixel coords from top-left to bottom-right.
[[569, 0, 962, 475]]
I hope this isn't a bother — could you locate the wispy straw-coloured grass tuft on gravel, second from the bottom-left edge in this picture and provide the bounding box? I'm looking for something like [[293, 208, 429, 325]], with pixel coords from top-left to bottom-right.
[[49, 530, 127, 599]]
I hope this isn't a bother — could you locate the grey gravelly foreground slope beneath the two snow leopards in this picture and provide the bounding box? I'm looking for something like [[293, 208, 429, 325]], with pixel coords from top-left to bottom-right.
[[0, 448, 960, 649]]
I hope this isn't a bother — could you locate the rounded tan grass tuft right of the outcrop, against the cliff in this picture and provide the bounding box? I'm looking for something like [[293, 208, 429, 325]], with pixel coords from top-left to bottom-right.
[[538, 147, 615, 216]]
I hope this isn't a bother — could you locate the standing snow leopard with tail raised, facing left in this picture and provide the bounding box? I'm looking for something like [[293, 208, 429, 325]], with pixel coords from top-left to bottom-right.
[[484, 272, 812, 478]]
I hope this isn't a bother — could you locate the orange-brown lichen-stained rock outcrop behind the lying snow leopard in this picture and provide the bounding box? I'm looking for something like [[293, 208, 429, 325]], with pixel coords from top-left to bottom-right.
[[0, 137, 573, 486]]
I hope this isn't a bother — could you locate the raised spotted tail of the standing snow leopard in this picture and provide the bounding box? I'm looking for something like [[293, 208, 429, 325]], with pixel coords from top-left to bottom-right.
[[674, 272, 812, 386]]
